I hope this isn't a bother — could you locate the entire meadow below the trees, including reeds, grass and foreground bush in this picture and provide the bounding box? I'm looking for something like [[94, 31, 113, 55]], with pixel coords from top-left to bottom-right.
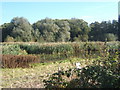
[[0, 42, 120, 88]]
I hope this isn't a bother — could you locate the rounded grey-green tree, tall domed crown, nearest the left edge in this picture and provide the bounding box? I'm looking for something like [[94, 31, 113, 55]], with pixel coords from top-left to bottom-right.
[[10, 17, 33, 42]]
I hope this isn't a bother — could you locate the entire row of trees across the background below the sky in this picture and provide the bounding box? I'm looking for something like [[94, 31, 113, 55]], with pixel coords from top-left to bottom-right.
[[0, 17, 118, 42]]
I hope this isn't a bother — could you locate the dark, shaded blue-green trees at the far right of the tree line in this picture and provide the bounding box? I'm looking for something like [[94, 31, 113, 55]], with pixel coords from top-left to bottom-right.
[[89, 20, 119, 41]]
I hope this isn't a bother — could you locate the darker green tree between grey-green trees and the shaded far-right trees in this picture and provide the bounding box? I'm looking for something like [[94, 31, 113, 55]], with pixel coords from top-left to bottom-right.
[[69, 19, 90, 41]]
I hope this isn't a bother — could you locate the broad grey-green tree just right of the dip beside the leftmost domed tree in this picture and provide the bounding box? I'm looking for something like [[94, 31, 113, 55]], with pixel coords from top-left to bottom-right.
[[33, 18, 59, 42]]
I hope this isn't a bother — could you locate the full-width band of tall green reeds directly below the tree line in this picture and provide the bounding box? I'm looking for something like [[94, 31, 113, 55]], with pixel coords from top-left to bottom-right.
[[2, 42, 119, 62]]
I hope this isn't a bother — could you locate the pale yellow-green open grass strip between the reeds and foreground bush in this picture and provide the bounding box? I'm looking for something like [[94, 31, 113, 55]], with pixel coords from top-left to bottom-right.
[[1, 58, 92, 88]]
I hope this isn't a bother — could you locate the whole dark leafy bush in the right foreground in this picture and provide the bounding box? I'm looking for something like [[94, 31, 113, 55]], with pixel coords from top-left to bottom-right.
[[43, 48, 120, 88]]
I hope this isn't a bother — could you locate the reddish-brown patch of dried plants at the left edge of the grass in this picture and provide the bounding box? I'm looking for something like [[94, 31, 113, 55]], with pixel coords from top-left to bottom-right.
[[0, 55, 39, 68]]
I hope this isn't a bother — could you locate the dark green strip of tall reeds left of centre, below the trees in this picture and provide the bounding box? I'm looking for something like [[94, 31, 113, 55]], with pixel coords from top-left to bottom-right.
[[21, 44, 73, 54]]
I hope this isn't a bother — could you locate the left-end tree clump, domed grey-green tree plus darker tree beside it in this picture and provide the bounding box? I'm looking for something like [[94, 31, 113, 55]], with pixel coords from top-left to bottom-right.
[[2, 17, 33, 42]]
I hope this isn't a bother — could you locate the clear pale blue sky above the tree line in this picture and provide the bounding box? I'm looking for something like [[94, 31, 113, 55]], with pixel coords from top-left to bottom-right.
[[0, 2, 118, 24]]
